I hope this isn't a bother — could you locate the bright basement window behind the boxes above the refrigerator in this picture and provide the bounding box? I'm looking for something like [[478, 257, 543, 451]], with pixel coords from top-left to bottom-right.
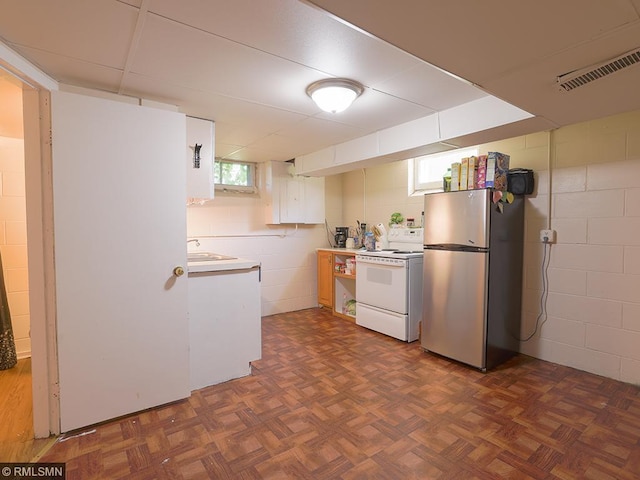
[[409, 147, 479, 195]]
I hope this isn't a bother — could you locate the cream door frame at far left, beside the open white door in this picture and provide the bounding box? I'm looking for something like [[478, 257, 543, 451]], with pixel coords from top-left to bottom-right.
[[0, 42, 60, 438]]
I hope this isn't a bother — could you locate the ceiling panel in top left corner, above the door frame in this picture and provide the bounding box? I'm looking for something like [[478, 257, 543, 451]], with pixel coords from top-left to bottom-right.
[[0, 0, 138, 68]]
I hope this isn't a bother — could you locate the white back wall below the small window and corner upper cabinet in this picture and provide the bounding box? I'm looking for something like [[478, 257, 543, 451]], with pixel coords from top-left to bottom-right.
[[187, 170, 342, 316]]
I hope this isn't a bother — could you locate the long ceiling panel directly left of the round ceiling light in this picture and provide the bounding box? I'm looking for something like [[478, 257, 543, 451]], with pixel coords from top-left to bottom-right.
[[131, 15, 319, 113]]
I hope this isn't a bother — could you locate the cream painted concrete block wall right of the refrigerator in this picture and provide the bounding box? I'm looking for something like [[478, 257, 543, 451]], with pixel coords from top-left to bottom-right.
[[482, 111, 640, 384]]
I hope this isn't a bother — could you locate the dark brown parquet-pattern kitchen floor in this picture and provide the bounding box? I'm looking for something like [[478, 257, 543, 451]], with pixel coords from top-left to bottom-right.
[[41, 309, 640, 480]]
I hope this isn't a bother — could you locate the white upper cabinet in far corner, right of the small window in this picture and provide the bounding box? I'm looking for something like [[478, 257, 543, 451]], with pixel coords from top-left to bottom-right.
[[263, 162, 325, 224]]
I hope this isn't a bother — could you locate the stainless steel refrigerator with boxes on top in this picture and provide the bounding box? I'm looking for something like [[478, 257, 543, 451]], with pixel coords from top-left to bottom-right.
[[421, 189, 524, 371]]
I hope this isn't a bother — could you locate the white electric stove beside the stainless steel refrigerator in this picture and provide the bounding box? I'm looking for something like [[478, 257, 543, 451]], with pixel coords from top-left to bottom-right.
[[356, 228, 423, 342]]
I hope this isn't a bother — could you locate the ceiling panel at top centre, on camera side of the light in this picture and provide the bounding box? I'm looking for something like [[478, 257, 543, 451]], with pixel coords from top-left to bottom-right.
[[150, 0, 417, 85]]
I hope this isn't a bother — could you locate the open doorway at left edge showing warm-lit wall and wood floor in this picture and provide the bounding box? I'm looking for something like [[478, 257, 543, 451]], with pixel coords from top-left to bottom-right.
[[0, 73, 40, 461]]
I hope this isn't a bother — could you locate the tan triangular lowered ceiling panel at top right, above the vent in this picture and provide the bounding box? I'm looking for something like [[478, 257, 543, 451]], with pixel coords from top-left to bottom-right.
[[313, 0, 638, 85]]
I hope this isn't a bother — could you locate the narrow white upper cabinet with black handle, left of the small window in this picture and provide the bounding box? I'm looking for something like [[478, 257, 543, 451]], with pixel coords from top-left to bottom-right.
[[185, 117, 215, 203]]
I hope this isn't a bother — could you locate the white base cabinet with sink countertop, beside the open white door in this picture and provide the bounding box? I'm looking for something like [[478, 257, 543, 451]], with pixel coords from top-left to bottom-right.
[[188, 259, 262, 391]]
